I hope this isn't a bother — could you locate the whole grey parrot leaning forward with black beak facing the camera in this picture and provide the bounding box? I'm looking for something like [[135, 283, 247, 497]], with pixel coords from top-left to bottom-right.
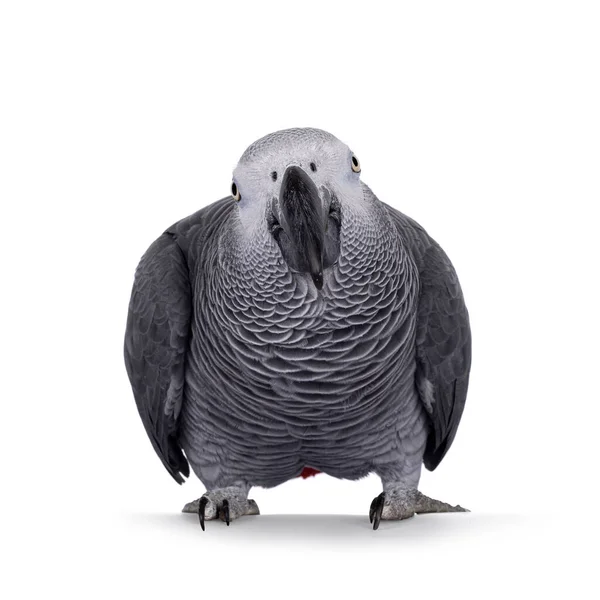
[[125, 129, 471, 529]]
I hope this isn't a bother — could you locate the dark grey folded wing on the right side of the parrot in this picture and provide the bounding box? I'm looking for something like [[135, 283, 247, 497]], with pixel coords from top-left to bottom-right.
[[390, 209, 471, 471]]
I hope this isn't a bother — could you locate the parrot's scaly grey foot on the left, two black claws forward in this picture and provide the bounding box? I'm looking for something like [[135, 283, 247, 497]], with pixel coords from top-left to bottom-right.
[[182, 487, 260, 531]]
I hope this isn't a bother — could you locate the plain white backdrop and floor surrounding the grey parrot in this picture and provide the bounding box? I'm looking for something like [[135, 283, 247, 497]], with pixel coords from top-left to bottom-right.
[[0, 0, 600, 599]]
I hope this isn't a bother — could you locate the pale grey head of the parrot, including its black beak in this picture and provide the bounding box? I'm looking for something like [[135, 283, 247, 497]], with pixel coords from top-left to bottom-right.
[[231, 129, 365, 290]]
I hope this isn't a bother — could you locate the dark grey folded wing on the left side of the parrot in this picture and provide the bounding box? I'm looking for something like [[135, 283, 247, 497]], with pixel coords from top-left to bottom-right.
[[125, 233, 191, 483]]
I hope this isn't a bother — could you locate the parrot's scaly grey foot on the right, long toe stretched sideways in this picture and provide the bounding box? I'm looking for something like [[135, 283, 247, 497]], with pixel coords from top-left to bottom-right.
[[369, 488, 469, 529]]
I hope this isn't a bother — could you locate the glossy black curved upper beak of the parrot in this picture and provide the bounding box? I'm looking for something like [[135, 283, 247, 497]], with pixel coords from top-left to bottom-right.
[[279, 166, 325, 290]]
